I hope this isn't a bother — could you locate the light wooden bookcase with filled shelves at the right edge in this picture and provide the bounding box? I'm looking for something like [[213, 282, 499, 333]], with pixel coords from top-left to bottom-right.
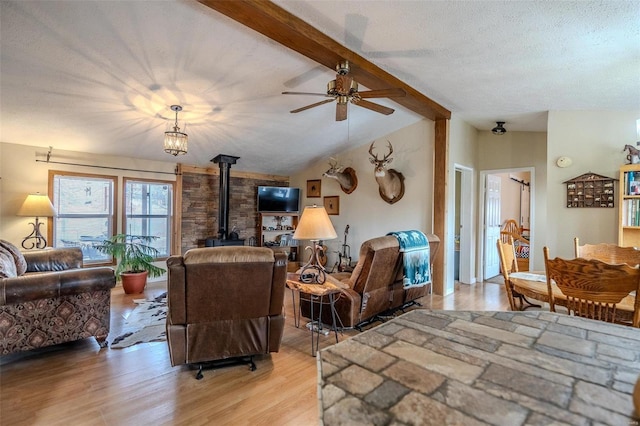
[[618, 164, 640, 247]]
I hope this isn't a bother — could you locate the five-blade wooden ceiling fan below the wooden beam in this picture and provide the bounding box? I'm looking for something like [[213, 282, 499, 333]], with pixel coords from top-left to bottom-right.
[[282, 61, 407, 121]]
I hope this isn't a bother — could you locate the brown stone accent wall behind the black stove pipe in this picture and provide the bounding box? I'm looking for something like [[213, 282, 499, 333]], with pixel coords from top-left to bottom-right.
[[181, 170, 289, 254]]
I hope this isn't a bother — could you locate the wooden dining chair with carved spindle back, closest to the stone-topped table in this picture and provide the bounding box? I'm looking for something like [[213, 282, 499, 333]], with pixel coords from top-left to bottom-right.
[[544, 247, 640, 327]]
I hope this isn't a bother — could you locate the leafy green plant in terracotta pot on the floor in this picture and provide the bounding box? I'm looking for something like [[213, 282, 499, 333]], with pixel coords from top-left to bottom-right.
[[96, 234, 165, 294]]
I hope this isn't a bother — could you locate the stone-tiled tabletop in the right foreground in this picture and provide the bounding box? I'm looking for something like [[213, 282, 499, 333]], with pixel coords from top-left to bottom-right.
[[317, 309, 640, 426]]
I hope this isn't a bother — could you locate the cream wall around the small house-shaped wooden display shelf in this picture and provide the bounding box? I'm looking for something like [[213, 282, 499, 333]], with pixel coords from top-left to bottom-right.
[[540, 110, 640, 257]]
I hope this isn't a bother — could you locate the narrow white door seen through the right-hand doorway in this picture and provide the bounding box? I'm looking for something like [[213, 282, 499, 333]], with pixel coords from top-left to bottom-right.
[[484, 175, 502, 279]]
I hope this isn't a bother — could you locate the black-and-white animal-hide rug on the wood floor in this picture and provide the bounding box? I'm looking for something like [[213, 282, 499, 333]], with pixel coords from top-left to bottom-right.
[[111, 293, 167, 349]]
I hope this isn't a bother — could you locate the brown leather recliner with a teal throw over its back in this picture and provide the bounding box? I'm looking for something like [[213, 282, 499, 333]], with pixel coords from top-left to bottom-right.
[[300, 234, 440, 329]]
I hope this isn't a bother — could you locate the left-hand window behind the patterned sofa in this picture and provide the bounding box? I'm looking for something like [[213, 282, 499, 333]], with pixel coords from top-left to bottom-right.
[[49, 170, 117, 264]]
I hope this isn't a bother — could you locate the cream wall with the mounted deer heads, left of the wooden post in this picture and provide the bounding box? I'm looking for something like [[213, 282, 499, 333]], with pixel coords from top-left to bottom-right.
[[290, 120, 434, 267]]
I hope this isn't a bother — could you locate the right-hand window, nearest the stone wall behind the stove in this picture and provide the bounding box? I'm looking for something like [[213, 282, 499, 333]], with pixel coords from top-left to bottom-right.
[[123, 178, 173, 257]]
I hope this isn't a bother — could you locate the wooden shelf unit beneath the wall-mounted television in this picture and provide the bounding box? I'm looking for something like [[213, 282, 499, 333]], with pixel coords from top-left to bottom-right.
[[257, 213, 300, 272]]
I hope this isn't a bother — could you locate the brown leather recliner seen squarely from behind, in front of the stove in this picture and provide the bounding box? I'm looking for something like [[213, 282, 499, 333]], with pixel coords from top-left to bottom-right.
[[167, 246, 287, 379]]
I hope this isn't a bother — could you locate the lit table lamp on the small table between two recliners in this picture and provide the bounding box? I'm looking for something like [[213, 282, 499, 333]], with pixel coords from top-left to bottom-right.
[[293, 205, 338, 284]]
